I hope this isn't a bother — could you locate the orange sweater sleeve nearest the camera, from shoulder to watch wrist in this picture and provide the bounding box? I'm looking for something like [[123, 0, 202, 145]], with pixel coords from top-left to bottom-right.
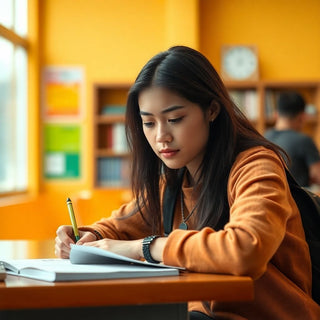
[[163, 147, 304, 278]]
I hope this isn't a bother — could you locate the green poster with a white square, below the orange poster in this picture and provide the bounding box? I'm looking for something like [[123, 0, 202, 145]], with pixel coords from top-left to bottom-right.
[[44, 124, 81, 179]]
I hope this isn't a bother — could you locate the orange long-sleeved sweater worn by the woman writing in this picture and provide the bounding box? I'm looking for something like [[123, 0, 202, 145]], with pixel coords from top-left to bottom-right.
[[82, 147, 320, 320]]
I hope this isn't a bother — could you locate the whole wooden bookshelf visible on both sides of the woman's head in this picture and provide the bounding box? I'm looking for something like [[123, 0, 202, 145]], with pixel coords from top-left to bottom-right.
[[93, 80, 320, 189]]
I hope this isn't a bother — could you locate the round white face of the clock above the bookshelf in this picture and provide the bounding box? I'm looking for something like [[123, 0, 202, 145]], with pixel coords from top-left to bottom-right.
[[222, 46, 258, 80]]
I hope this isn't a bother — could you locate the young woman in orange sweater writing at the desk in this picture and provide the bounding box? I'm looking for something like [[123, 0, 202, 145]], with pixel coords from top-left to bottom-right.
[[55, 46, 320, 320]]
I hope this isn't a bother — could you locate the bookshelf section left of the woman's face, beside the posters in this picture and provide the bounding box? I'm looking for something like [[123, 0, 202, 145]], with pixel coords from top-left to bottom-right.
[[93, 83, 130, 188]]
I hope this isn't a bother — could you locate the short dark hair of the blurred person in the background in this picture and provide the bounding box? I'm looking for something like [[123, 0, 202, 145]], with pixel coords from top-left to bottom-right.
[[277, 91, 306, 118]]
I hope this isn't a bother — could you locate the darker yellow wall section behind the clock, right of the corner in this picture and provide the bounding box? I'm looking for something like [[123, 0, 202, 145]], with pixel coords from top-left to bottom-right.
[[200, 0, 320, 80]]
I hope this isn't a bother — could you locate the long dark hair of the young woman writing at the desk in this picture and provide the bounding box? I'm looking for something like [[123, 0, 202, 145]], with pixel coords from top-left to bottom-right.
[[126, 46, 281, 233]]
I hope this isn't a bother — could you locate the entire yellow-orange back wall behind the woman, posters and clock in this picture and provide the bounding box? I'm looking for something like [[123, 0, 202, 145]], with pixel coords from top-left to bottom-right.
[[0, 0, 320, 238]]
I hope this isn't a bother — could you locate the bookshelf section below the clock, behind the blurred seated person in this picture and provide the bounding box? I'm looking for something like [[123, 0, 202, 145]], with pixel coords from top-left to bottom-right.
[[225, 80, 320, 148]]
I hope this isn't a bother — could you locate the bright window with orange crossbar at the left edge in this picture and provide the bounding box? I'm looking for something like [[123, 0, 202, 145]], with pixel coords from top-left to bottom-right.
[[0, 0, 28, 195]]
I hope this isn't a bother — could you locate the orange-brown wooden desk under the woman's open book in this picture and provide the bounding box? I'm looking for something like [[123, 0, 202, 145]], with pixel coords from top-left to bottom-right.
[[0, 241, 253, 320]]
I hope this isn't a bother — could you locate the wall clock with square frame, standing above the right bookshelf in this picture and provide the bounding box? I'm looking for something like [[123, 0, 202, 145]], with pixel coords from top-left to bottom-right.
[[221, 45, 259, 81]]
